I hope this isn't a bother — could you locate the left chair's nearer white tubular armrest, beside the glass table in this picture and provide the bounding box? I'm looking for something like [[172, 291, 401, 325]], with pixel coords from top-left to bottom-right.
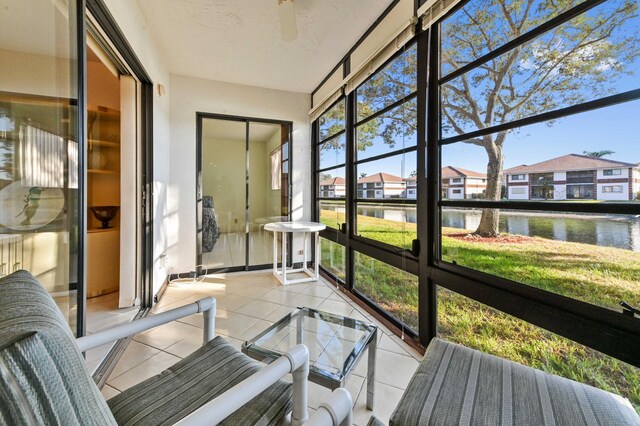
[[175, 345, 309, 426]]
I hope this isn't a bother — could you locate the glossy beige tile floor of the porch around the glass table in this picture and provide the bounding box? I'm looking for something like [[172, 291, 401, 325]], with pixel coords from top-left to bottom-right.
[[102, 270, 422, 425]]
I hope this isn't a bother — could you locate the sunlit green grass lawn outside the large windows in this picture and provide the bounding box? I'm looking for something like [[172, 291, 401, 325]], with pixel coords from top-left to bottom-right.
[[321, 211, 640, 413]]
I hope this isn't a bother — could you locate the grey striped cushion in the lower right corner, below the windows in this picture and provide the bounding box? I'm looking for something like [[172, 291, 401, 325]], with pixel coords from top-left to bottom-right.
[[389, 339, 640, 426]]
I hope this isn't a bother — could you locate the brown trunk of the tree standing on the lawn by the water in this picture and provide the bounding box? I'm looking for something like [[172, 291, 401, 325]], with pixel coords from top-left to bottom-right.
[[474, 141, 504, 237]]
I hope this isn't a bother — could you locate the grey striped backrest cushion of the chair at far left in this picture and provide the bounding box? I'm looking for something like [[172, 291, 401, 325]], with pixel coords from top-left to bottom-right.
[[0, 271, 116, 425]]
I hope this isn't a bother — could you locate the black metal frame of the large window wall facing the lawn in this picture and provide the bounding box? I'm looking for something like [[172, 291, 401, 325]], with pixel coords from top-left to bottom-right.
[[314, 0, 640, 366]]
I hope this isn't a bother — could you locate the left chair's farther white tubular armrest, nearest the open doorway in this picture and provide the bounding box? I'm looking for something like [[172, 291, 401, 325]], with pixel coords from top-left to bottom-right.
[[76, 297, 216, 352]]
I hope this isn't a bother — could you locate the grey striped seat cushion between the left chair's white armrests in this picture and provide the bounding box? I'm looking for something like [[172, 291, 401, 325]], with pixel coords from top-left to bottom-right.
[[108, 337, 291, 425]]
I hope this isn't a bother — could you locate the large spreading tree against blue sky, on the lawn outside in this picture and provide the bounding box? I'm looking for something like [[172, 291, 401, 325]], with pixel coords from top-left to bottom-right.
[[441, 0, 640, 236]]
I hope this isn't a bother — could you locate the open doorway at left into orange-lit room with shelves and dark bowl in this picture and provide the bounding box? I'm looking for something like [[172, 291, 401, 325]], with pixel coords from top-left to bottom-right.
[[85, 25, 142, 371]]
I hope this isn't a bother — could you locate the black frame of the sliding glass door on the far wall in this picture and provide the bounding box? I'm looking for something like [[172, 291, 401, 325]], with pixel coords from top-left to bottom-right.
[[195, 112, 293, 275]]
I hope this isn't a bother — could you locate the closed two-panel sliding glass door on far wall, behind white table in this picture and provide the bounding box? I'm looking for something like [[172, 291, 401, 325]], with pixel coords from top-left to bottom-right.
[[197, 113, 292, 272]]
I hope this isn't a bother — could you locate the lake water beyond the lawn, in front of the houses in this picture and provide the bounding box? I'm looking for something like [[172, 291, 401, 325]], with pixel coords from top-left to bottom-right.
[[322, 204, 640, 251]]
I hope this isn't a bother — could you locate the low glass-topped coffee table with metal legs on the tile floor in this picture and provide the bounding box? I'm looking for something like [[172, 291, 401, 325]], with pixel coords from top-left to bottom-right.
[[242, 308, 378, 410]]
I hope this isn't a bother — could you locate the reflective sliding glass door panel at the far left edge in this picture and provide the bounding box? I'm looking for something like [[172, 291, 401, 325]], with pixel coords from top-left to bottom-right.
[[0, 0, 83, 331]]
